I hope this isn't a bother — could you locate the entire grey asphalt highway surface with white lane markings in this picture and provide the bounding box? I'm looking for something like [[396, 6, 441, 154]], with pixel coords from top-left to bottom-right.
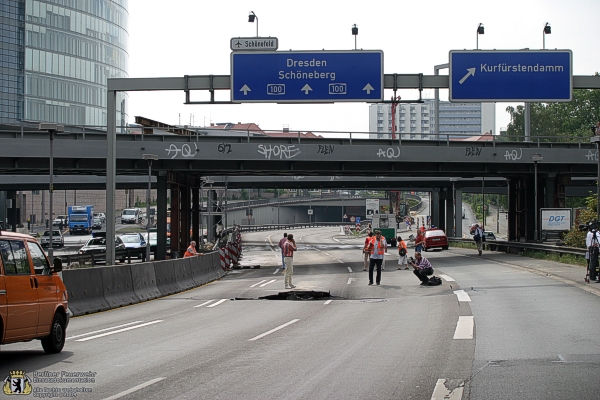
[[0, 228, 600, 400]]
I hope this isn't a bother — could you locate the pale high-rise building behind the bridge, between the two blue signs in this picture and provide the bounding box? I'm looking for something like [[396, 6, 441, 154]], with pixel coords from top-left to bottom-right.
[[369, 99, 496, 139]]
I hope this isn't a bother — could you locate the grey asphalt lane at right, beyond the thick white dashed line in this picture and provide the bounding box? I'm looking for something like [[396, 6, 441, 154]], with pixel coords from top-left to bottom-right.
[[438, 249, 600, 399]]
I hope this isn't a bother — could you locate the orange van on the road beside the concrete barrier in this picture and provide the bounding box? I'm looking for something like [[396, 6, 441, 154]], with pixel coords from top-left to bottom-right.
[[0, 231, 69, 353]]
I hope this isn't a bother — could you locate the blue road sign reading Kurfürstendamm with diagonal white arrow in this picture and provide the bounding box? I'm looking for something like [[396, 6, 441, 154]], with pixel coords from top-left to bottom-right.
[[450, 50, 573, 102]]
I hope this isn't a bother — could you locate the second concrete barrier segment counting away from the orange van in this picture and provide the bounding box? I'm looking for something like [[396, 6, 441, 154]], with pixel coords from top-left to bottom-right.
[[100, 265, 140, 308]]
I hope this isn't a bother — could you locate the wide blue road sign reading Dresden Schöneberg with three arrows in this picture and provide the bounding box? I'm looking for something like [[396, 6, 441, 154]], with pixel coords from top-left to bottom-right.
[[231, 50, 383, 103]]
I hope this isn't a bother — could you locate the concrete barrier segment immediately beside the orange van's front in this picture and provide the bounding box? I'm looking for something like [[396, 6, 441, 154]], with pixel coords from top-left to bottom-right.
[[63, 268, 110, 316]]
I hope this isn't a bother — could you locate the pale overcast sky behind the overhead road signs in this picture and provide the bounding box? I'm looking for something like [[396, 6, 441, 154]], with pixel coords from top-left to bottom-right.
[[124, 0, 600, 132]]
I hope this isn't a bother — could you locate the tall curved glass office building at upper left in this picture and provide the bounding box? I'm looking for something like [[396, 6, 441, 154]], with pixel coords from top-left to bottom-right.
[[0, 0, 129, 127]]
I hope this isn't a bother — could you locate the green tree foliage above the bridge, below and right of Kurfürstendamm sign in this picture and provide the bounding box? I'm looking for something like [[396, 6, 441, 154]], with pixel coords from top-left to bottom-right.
[[503, 85, 600, 141]]
